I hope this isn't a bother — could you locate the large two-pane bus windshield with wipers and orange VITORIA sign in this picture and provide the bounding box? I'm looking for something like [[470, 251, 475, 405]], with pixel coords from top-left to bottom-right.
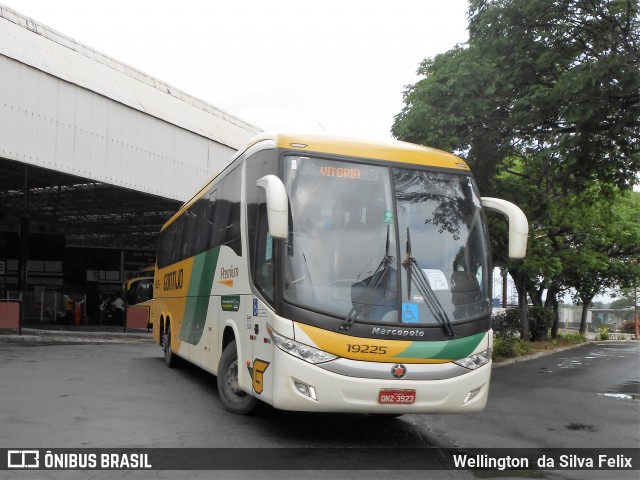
[[282, 156, 490, 328]]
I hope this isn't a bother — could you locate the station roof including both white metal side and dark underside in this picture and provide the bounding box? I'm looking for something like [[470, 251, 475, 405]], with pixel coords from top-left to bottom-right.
[[0, 5, 260, 248]]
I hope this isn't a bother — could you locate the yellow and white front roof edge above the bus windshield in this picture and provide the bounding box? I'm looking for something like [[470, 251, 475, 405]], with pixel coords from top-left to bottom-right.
[[248, 132, 469, 170]]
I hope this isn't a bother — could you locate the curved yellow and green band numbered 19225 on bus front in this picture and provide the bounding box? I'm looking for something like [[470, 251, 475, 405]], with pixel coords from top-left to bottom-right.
[[298, 324, 487, 363]]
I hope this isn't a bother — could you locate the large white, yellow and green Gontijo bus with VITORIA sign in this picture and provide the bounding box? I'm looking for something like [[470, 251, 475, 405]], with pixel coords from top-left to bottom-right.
[[153, 133, 528, 417]]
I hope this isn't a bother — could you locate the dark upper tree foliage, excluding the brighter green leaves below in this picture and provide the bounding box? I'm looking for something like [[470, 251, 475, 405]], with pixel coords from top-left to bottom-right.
[[392, 0, 640, 193]]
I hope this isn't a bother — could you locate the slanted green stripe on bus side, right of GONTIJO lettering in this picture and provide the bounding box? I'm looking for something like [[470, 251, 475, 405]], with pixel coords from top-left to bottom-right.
[[180, 247, 220, 345]]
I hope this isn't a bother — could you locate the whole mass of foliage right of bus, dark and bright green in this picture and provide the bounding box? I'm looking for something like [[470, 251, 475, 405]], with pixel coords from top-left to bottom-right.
[[392, 0, 640, 338]]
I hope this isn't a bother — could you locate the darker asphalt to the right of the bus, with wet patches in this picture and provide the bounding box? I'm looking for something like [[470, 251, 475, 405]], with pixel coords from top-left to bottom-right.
[[412, 342, 640, 448]]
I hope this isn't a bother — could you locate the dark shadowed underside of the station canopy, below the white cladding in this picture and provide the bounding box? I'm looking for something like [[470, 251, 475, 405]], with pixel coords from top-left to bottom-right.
[[0, 158, 181, 250]]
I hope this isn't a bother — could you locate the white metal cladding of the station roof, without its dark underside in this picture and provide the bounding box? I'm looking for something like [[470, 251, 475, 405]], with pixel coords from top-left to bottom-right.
[[0, 6, 260, 200]]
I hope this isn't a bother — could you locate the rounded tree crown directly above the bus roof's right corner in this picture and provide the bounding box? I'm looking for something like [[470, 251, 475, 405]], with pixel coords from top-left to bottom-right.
[[392, 46, 510, 194]]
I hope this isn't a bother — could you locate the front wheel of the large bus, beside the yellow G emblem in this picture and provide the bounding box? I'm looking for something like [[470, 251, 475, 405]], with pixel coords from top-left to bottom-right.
[[217, 340, 258, 415]]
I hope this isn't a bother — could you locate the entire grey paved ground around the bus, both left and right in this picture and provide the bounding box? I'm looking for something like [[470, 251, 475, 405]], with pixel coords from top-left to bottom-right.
[[0, 339, 640, 479]]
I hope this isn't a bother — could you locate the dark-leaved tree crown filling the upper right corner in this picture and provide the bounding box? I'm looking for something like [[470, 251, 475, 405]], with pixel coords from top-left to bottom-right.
[[469, 0, 640, 195]]
